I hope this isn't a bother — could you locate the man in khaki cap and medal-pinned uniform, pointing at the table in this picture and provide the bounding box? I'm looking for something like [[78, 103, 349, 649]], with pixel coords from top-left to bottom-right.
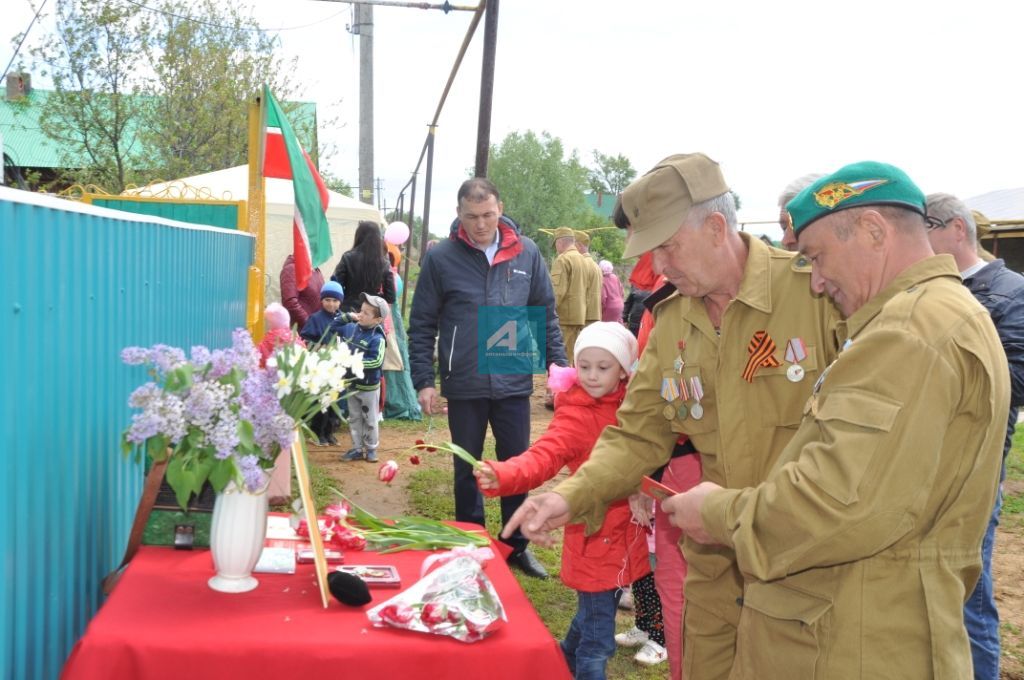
[[501, 154, 838, 680]]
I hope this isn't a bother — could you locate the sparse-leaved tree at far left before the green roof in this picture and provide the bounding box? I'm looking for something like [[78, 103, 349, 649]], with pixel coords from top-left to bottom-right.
[[31, 0, 152, 193]]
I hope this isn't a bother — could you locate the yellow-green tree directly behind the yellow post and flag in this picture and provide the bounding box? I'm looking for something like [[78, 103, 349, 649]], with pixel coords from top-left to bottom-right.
[[142, 0, 299, 177]]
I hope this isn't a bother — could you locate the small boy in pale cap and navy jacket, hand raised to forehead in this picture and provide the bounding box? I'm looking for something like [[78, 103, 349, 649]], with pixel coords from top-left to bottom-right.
[[338, 293, 390, 463]]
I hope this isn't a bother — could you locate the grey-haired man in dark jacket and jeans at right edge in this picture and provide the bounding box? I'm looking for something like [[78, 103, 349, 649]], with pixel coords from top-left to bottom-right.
[[928, 194, 1024, 680]]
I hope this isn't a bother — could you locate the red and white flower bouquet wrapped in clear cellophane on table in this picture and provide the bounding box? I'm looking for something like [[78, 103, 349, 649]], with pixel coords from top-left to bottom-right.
[[367, 557, 508, 642]]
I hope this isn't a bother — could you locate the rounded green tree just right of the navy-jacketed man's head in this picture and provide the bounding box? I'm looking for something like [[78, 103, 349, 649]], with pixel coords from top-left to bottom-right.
[[488, 131, 590, 239]]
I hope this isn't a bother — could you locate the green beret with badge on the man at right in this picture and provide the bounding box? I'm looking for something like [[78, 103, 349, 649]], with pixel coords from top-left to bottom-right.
[[785, 161, 927, 233]]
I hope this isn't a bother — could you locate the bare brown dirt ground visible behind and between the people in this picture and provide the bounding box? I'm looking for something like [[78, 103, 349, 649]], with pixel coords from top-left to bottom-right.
[[308, 378, 1024, 680]]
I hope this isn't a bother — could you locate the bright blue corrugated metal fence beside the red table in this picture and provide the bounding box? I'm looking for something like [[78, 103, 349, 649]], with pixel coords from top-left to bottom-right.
[[0, 183, 253, 680]]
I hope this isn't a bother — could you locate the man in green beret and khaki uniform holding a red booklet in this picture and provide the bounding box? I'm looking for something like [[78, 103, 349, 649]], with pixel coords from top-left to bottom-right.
[[663, 162, 1010, 680]]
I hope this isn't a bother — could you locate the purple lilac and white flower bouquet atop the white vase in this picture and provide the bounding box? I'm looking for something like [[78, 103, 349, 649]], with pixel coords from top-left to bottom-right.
[[121, 329, 362, 508]]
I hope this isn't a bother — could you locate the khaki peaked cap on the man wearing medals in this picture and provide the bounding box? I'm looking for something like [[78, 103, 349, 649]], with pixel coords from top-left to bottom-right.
[[622, 154, 729, 257]]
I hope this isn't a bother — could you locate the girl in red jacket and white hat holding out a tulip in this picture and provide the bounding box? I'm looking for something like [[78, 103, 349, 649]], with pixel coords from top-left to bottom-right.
[[474, 322, 650, 680]]
